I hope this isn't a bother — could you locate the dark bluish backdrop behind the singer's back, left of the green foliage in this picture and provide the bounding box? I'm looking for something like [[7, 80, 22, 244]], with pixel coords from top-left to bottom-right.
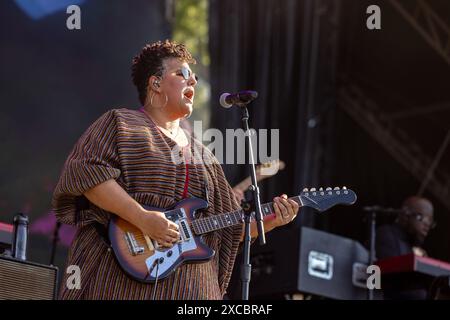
[[0, 0, 171, 271]]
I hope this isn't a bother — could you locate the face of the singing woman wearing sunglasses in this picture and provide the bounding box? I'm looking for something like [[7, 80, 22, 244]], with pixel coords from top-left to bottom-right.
[[160, 58, 197, 119]]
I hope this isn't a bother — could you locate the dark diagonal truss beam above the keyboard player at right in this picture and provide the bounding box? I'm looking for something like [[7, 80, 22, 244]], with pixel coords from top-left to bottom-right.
[[337, 84, 450, 210]]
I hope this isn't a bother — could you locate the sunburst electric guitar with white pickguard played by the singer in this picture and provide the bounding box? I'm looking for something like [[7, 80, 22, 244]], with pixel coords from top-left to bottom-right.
[[108, 187, 356, 283]]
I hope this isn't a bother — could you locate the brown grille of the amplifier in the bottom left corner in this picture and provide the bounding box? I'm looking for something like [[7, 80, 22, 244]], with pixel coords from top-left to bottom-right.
[[0, 256, 58, 300]]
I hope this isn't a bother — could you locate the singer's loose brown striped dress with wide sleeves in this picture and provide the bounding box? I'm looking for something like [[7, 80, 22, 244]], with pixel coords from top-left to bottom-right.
[[52, 109, 242, 299]]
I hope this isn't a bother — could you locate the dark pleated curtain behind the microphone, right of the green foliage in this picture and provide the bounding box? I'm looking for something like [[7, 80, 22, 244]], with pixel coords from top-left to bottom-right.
[[210, 0, 337, 298]]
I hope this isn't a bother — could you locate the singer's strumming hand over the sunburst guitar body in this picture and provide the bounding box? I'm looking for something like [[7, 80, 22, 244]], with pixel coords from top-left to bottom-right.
[[137, 209, 180, 248]]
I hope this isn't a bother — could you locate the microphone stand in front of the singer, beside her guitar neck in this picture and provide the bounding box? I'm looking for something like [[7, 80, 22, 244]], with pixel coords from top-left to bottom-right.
[[237, 103, 266, 300]]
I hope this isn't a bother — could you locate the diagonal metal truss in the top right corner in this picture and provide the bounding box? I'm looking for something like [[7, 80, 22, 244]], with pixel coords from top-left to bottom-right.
[[389, 0, 450, 65]]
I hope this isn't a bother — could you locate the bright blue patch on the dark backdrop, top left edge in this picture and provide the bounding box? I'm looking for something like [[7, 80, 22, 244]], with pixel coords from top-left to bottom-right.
[[14, 0, 86, 20]]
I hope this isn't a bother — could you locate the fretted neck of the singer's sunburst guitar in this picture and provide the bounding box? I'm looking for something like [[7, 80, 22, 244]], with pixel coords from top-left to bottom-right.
[[191, 196, 304, 235]]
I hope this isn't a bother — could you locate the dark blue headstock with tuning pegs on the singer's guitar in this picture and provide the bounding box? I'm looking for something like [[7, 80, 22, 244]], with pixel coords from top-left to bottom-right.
[[300, 187, 357, 211]]
